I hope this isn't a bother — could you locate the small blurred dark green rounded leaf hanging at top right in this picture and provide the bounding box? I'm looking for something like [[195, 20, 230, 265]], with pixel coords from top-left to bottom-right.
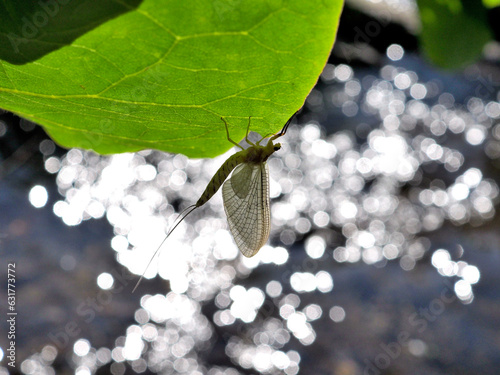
[[418, 0, 492, 69]]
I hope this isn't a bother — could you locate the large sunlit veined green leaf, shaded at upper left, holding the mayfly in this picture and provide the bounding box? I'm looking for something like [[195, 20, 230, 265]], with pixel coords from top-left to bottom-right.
[[0, 0, 342, 157]]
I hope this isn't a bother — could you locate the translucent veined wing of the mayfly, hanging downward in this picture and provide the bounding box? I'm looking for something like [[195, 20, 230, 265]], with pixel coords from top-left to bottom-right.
[[222, 162, 271, 257]]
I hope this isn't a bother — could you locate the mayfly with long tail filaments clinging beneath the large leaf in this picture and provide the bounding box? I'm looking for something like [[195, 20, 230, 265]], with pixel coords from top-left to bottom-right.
[[132, 115, 295, 293]]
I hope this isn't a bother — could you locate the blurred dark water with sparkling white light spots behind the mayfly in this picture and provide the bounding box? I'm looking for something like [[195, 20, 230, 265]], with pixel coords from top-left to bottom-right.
[[0, 2, 500, 375]]
